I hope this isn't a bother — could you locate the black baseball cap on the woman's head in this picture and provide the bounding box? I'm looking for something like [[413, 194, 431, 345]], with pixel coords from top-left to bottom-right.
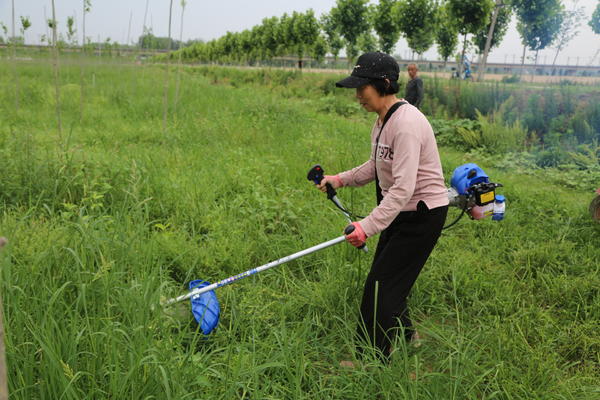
[[335, 51, 400, 88]]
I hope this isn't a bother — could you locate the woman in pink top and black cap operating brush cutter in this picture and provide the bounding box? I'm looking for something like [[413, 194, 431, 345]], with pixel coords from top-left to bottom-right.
[[318, 52, 448, 365]]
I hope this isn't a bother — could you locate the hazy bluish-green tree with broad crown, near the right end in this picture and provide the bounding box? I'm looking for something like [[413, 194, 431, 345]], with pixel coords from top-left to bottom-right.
[[513, 0, 564, 76]]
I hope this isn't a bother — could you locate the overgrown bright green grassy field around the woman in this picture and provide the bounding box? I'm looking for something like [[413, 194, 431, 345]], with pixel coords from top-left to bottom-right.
[[0, 57, 600, 400]]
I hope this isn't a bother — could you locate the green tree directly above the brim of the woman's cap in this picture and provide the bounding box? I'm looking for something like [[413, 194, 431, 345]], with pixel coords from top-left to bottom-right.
[[331, 0, 370, 62]]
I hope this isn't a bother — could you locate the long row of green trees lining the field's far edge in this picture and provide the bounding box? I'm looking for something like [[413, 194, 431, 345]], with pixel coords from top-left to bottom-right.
[[165, 0, 600, 79]]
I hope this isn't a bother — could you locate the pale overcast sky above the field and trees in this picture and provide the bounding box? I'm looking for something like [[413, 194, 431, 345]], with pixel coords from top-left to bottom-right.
[[0, 0, 600, 65]]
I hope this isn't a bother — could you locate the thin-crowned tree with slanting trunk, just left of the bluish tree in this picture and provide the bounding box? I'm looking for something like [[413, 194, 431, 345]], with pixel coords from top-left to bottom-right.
[[474, 0, 512, 81]]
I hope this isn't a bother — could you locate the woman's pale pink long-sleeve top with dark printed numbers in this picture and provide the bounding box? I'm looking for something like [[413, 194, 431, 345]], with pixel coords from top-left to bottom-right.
[[339, 104, 448, 236]]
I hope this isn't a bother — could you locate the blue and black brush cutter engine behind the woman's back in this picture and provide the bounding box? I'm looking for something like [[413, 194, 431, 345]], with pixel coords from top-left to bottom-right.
[[448, 163, 506, 221]]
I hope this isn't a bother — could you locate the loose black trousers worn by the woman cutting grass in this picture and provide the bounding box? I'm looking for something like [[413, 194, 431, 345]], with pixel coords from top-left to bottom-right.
[[357, 201, 448, 357]]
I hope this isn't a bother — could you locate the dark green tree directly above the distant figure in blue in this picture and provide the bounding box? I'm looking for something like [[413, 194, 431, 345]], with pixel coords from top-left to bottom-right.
[[448, 0, 494, 76]]
